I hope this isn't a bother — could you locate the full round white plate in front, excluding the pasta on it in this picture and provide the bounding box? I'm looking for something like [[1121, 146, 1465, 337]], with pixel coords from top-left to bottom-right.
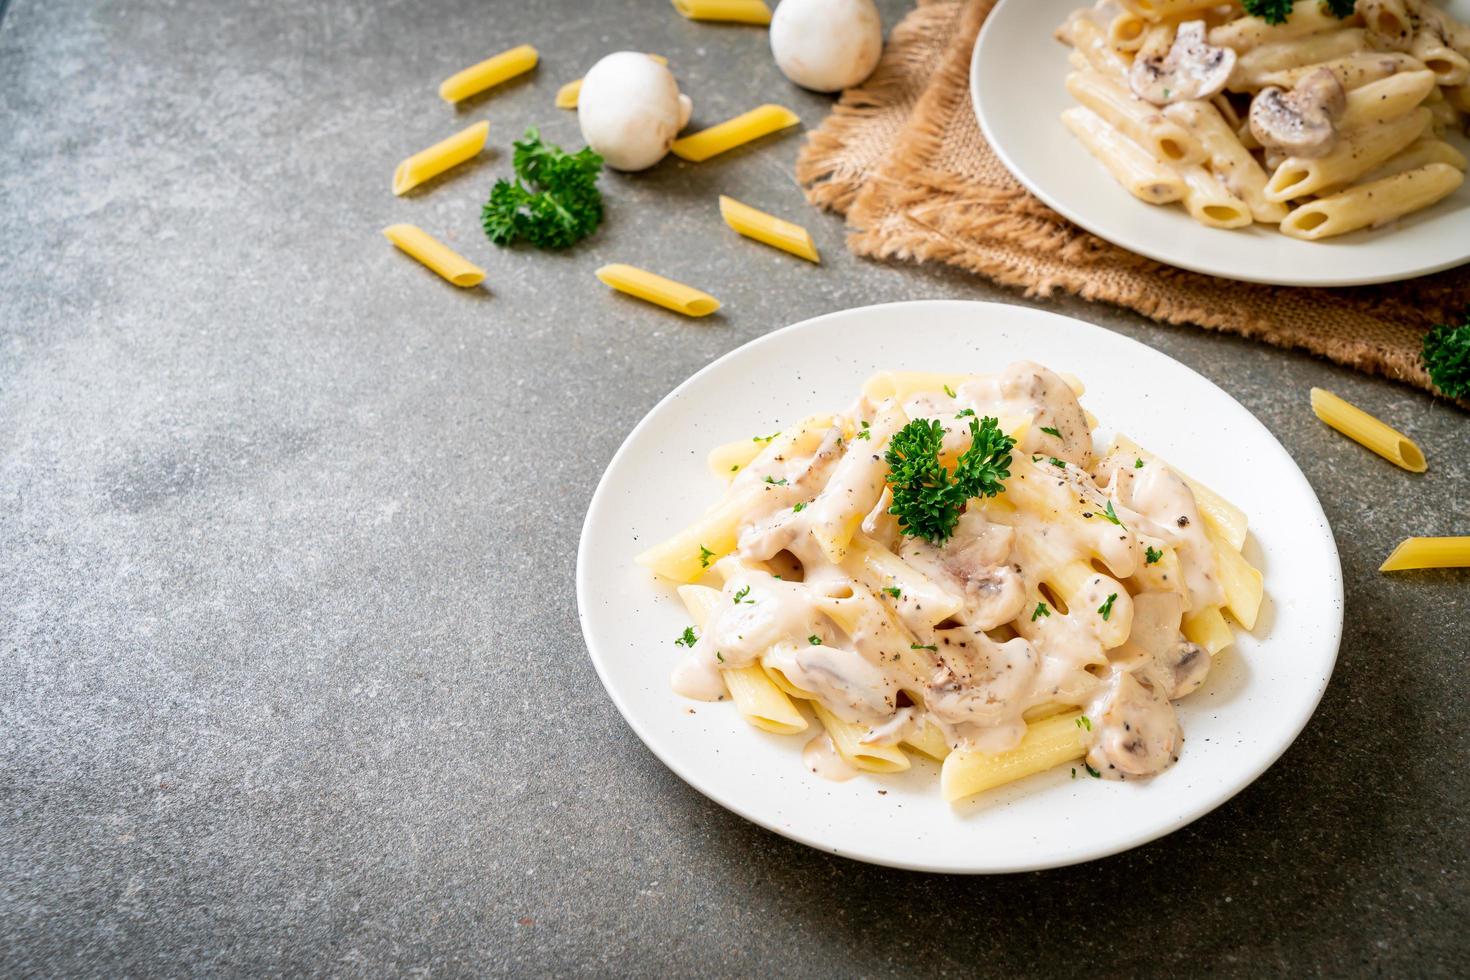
[[576, 301, 1342, 873]]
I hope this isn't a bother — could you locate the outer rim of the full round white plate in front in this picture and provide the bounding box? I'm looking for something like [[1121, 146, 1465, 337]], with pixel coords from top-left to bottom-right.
[[575, 300, 1345, 876]]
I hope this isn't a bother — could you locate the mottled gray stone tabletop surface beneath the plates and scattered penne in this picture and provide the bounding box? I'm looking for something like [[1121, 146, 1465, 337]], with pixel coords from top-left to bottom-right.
[[0, 0, 1470, 977]]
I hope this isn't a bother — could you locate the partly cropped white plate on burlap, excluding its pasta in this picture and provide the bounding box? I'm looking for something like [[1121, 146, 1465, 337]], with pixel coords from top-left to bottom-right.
[[970, 0, 1470, 287]]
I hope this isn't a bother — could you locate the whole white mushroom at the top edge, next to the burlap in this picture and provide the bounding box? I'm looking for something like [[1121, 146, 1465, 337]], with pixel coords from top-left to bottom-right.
[[770, 0, 883, 93]]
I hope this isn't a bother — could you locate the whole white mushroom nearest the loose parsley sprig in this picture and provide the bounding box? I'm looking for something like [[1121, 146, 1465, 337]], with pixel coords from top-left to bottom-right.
[[576, 51, 694, 170]]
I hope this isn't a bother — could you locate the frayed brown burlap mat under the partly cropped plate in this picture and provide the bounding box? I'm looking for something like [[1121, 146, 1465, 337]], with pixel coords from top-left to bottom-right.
[[797, 0, 1470, 391]]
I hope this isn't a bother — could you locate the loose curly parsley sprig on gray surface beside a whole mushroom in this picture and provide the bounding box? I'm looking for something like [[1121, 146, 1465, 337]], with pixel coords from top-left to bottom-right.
[[479, 126, 603, 248]]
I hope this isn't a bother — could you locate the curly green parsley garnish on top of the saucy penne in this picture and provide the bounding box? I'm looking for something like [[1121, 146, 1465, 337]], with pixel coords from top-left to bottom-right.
[[885, 416, 1016, 545]]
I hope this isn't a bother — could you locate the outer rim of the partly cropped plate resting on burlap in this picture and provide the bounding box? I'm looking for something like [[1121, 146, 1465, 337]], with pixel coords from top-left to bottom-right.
[[967, 0, 1470, 289]]
